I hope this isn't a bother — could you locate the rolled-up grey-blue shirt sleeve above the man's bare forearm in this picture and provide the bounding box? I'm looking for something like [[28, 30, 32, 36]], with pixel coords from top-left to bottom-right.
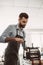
[[0, 25, 11, 43]]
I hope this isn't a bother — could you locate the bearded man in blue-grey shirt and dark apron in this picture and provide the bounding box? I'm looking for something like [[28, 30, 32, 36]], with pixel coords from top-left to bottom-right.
[[0, 13, 28, 65]]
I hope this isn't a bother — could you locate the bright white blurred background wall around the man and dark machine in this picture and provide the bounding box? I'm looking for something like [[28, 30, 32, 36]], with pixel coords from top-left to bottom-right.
[[0, 0, 43, 64]]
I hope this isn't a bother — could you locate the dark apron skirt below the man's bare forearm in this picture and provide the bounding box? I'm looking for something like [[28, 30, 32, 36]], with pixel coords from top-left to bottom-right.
[[4, 42, 20, 65]]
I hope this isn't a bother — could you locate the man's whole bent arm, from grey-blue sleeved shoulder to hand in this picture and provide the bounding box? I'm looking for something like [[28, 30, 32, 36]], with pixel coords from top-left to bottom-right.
[[0, 25, 24, 43]]
